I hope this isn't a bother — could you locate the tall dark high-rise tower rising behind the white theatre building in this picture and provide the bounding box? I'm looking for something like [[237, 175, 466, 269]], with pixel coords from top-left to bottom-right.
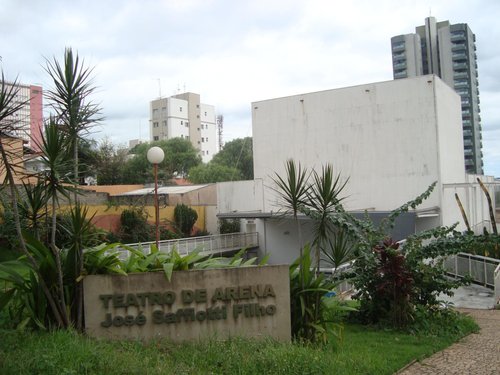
[[391, 17, 483, 174]]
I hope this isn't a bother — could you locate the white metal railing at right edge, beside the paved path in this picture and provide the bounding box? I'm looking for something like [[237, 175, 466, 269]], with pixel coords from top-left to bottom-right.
[[444, 253, 500, 293]]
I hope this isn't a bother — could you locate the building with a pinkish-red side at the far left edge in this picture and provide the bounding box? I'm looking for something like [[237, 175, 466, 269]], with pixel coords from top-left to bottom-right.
[[3, 82, 43, 151]]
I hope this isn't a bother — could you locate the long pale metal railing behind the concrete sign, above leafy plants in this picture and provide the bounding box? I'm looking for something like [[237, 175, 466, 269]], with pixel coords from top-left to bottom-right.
[[118, 232, 259, 254]]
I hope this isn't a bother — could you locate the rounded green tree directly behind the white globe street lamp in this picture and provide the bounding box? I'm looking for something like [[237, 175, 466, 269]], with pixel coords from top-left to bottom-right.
[[124, 138, 201, 184]]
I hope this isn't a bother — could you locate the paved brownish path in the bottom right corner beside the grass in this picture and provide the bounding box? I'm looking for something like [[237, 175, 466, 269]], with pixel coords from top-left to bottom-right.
[[398, 309, 500, 375]]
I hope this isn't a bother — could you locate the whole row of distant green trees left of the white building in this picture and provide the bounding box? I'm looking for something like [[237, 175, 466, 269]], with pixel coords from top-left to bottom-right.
[[83, 137, 253, 185]]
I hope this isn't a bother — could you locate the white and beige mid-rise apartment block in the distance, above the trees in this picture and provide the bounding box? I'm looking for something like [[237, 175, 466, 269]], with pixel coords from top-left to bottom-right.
[[150, 92, 217, 163]]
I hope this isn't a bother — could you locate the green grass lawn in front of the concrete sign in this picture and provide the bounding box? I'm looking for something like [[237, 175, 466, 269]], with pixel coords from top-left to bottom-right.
[[0, 318, 477, 375]]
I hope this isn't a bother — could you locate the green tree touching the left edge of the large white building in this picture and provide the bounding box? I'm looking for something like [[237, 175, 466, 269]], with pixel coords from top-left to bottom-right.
[[210, 137, 253, 180]]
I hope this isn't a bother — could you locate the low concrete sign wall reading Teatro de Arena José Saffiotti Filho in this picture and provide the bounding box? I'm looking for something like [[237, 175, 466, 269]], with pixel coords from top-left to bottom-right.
[[84, 266, 290, 342]]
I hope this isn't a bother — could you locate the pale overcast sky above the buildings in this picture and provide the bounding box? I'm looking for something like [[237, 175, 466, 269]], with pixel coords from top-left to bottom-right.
[[0, 0, 500, 177]]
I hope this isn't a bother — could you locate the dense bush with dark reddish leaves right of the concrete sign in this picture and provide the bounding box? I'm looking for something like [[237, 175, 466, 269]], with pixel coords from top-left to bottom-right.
[[343, 183, 469, 327]]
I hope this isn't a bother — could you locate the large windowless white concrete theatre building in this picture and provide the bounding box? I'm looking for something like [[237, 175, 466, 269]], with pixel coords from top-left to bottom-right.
[[218, 75, 493, 263]]
